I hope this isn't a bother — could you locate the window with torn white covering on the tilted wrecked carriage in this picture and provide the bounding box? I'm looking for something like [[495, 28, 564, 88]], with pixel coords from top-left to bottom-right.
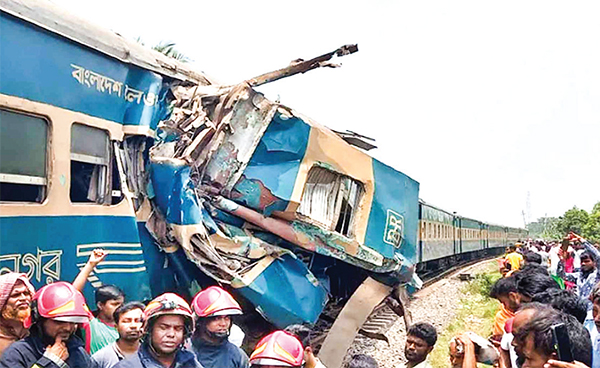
[[298, 167, 364, 236]]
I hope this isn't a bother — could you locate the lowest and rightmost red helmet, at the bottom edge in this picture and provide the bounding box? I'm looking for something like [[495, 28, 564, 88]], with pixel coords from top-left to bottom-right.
[[250, 331, 304, 367]]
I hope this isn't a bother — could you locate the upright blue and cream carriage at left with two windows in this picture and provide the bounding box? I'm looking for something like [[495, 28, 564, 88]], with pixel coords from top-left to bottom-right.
[[0, 1, 216, 300]]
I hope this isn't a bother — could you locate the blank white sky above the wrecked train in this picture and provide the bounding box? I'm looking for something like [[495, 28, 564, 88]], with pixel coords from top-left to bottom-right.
[[52, 0, 600, 227]]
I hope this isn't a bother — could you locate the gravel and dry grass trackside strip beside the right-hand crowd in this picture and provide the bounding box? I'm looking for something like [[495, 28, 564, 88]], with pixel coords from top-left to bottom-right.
[[347, 260, 500, 368]]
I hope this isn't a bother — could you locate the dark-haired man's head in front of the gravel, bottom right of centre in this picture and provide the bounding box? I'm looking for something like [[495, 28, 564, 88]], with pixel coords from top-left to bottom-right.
[[404, 322, 437, 368]]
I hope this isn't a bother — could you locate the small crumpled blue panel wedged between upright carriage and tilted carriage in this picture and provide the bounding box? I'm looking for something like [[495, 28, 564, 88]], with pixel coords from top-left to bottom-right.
[[150, 162, 203, 225]]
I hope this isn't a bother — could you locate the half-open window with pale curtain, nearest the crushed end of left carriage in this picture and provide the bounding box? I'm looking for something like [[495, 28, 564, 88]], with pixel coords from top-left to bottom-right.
[[70, 123, 112, 204]]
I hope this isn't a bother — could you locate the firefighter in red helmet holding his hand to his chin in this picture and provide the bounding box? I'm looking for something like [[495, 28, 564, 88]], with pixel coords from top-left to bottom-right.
[[0, 282, 95, 368]]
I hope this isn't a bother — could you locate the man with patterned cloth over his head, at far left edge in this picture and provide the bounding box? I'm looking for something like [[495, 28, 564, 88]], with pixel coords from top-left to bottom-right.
[[0, 272, 35, 357]]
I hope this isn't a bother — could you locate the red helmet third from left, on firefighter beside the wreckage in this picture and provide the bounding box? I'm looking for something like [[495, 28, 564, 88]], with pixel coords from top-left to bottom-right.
[[192, 286, 242, 317]]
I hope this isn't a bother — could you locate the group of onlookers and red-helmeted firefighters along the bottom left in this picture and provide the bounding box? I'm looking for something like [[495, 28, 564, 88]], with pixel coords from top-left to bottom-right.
[[0, 249, 328, 368]]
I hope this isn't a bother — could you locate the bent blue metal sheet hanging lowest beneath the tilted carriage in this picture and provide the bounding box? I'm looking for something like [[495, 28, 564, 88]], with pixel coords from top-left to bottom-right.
[[237, 255, 327, 328]]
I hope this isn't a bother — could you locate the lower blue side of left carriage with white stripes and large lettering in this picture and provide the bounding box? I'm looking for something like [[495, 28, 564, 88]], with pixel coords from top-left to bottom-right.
[[0, 216, 151, 306]]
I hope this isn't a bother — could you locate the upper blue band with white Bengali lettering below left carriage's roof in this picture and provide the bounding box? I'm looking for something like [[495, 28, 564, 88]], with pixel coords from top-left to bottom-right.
[[0, 12, 171, 129]]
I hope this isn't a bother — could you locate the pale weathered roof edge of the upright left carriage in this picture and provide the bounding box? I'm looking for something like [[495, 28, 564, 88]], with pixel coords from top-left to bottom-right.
[[0, 0, 215, 85]]
